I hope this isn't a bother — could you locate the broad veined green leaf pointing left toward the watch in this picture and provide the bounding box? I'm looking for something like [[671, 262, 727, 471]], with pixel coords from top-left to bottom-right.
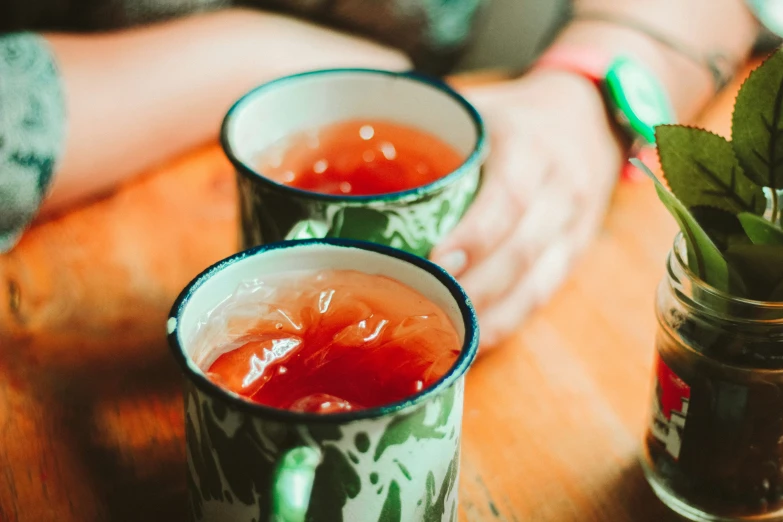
[[655, 125, 767, 214]]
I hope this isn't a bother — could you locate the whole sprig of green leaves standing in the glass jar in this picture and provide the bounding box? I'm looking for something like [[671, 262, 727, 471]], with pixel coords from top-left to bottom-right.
[[644, 51, 783, 301]]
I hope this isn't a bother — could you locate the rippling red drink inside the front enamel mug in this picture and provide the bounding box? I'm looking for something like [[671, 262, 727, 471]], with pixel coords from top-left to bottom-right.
[[202, 270, 460, 413]]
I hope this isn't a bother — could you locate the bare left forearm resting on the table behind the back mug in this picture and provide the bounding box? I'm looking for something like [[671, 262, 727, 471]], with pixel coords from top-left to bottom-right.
[[43, 10, 408, 212]]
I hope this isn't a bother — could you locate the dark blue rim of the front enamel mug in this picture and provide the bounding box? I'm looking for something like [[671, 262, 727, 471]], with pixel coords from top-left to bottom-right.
[[167, 238, 479, 424]]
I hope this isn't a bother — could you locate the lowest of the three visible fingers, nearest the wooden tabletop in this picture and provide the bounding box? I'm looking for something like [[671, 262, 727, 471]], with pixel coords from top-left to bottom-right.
[[479, 236, 574, 350]]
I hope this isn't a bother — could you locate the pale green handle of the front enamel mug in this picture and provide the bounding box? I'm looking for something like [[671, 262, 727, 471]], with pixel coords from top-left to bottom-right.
[[270, 446, 322, 522]]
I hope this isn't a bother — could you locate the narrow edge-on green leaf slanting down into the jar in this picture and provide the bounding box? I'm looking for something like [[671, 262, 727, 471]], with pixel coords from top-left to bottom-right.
[[631, 158, 729, 292]]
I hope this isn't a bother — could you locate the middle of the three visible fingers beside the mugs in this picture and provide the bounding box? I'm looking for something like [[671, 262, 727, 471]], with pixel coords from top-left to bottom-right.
[[460, 177, 581, 309]]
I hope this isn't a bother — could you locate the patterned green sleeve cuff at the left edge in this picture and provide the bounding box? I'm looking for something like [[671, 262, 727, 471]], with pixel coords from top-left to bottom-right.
[[0, 33, 65, 253]]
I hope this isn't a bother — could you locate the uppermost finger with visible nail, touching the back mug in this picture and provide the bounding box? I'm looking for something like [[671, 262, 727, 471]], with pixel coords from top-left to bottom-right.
[[430, 140, 548, 276]]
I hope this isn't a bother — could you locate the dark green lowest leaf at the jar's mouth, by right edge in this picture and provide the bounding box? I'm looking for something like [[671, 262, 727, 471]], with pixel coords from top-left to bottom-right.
[[725, 245, 783, 301]]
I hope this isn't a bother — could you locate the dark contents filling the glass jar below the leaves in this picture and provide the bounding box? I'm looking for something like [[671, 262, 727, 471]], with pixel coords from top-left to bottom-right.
[[645, 330, 783, 517]]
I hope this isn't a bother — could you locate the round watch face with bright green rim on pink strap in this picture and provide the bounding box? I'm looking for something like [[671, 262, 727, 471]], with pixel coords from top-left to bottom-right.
[[604, 58, 674, 144]]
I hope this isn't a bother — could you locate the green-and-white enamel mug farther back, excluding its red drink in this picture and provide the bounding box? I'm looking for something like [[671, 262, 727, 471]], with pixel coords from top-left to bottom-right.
[[221, 69, 488, 256]]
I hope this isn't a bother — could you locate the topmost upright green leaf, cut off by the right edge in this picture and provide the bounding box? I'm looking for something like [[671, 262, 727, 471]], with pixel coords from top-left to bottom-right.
[[731, 52, 783, 188]]
